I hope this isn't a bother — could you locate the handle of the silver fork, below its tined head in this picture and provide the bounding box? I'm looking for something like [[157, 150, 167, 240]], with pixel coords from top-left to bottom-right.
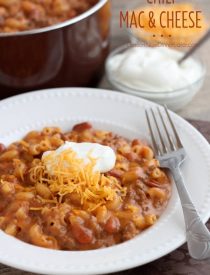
[[171, 167, 210, 260]]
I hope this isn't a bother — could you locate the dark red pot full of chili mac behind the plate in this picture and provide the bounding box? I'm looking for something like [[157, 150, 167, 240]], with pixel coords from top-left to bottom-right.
[[0, 0, 110, 98]]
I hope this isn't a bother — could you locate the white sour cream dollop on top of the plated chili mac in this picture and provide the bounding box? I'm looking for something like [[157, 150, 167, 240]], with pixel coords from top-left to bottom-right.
[[42, 141, 116, 173]]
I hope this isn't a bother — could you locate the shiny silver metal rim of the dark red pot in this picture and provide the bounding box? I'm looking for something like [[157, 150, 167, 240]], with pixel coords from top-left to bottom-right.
[[0, 0, 109, 38]]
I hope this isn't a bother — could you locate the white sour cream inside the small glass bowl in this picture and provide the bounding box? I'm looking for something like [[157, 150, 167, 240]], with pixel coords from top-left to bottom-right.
[[107, 47, 202, 92]]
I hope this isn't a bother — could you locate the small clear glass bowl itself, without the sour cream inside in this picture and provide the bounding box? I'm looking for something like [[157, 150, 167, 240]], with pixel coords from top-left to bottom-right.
[[106, 44, 206, 111]]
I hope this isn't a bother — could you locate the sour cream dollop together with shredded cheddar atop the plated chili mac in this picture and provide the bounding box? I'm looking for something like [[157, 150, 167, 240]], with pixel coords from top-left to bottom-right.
[[30, 142, 126, 211]]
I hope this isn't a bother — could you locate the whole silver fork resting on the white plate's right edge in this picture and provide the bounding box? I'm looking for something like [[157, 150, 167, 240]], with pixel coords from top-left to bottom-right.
[[146, 107, 210, 260]]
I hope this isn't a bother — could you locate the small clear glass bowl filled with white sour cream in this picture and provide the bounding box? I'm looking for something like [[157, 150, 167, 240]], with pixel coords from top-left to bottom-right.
[[106, 44, 206, 111]]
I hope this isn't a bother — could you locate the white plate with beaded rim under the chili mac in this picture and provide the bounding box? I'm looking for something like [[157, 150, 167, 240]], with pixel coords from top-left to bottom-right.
[[0, 88, 210, 275]]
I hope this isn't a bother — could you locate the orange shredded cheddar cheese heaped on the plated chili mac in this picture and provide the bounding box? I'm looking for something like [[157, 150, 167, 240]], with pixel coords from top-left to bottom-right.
[[30, 149, 126, 211]]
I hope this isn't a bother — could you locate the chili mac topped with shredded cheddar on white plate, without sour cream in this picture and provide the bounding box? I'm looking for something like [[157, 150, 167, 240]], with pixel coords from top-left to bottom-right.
[[0, 122, 171, 250]]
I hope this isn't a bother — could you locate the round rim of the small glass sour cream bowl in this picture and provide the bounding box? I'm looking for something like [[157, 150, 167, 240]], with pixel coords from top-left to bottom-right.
[[105, 43, 207, 97]]
